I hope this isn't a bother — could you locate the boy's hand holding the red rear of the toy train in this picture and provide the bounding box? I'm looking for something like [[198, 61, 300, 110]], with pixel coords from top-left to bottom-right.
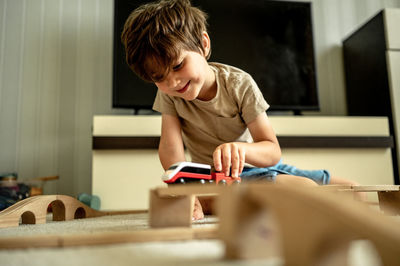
[[213, 142, 246, 178]]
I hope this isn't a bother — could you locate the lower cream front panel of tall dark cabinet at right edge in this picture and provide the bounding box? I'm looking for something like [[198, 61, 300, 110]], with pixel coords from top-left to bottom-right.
[[386, 51, 400, 178]]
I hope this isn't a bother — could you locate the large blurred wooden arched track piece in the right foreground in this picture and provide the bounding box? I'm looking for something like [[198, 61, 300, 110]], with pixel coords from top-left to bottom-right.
[[218, 184, 400, 265]]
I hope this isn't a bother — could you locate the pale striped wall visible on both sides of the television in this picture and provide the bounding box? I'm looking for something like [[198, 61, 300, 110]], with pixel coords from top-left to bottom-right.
[[0, 0, 400, 195]]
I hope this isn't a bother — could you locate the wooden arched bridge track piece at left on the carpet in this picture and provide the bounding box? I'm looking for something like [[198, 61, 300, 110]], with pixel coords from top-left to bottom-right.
[[0, 195, 143, 228]]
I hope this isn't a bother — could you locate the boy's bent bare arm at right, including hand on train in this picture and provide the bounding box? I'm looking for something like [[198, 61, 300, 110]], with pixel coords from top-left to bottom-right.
[[213, 112, 281, 177]]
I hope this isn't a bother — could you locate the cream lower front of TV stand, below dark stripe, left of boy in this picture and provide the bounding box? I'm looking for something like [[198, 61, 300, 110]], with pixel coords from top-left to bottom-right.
[[92, 149, 166, 210]]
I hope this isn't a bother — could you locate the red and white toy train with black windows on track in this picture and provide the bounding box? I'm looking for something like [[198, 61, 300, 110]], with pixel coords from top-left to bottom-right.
[[162, 162, 241, 185]]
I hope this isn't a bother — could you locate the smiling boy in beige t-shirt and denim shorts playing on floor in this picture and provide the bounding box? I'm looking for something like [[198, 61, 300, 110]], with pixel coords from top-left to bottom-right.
[[121, 0, 353, 219]]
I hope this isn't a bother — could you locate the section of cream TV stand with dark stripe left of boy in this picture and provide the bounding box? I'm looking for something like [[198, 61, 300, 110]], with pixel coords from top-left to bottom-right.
[[92, 116, 164, 210]]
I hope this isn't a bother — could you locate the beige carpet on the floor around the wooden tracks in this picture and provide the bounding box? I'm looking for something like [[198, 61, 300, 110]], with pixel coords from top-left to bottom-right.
[[0, 214, 379, 266]]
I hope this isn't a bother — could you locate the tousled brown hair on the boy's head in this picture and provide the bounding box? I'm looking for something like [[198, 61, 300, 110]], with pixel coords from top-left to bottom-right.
[[121, 0, 210, 82]]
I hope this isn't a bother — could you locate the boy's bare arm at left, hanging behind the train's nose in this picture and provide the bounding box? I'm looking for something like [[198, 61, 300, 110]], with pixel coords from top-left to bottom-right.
[[158, 114, 186, 170]]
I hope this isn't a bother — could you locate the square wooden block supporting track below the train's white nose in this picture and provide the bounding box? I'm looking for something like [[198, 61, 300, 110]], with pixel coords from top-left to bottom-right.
[[149, 189, 195, 227]]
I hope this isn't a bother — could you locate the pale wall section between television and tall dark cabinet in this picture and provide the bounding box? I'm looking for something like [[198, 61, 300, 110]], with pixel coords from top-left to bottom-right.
[[306, 0, 400, 115]]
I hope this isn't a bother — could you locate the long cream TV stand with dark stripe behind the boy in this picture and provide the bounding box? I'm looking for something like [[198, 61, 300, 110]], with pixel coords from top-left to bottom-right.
[[92, 115, 394, 210]]
